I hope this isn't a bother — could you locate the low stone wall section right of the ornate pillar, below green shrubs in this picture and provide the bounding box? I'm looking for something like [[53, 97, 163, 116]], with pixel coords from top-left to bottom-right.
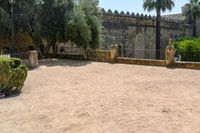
[[175, 62, 200, 70]]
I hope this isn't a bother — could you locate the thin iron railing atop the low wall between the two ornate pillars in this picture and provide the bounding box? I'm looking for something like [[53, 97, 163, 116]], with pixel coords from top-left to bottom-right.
[[119, 49, 165, 60]]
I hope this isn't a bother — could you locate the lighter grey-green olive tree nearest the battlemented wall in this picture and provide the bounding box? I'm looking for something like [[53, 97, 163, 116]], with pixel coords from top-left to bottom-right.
[[66, 0, 102, 58]]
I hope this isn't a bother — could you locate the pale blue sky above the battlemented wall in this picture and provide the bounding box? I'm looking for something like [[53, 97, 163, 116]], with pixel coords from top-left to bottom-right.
[[99, 0, 189, 15]]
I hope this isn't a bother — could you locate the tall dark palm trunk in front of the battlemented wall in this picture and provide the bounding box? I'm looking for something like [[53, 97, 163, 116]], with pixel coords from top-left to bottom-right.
[[156, 10, 161, 59]]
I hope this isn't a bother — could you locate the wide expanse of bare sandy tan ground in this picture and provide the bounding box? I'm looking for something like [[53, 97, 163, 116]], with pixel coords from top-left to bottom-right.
[[0, 60, 200, 133]]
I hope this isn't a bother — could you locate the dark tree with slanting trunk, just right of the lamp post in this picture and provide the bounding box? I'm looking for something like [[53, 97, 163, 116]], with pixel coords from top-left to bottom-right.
[[15, 0, 44, 57]]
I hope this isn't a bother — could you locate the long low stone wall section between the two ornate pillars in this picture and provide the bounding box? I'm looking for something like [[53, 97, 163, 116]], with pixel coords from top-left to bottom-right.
[[116, 57, 166, 66]]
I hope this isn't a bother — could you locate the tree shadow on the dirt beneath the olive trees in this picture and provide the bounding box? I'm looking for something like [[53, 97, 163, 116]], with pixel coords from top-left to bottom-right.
[[39, 58, 91, 67]]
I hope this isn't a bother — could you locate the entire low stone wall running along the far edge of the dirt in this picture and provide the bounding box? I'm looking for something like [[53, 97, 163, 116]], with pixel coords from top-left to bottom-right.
[[49, 48, 200, 70]]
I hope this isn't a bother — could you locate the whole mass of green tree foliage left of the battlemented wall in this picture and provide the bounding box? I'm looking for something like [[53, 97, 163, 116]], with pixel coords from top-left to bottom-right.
[[0, 0, 102, 55]]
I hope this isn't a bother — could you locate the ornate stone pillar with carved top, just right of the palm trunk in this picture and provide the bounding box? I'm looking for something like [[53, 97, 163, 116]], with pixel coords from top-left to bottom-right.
[[165, 39, 175, 67]]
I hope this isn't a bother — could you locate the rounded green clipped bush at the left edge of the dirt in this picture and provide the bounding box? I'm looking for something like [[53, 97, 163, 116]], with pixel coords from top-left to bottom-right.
[[0, 58, 27, 96]]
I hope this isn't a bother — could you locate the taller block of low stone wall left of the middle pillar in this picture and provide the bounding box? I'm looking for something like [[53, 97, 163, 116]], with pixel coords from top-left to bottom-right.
[[87, 50, 110, 62]]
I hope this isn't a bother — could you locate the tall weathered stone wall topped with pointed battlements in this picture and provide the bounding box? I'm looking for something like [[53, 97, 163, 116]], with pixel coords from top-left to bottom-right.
[[102, 9, 192, 58]]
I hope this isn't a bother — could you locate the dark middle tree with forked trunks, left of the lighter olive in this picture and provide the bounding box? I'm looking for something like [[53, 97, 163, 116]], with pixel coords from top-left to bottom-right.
[[40, 0, 74, 54]]
